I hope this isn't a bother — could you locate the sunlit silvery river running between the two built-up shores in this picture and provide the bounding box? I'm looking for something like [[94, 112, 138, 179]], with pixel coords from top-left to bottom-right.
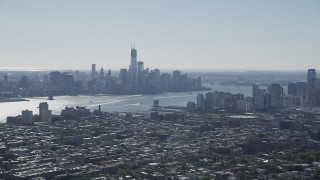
[[0, 85, 264, 122]]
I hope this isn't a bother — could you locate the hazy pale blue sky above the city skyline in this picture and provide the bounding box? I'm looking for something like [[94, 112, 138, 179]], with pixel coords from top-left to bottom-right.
[[0, 0, 320, 70]]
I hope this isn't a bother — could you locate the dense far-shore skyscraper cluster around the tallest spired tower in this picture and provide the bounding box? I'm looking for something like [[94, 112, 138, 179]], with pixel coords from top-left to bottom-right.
[[117, 48, 202, 93]]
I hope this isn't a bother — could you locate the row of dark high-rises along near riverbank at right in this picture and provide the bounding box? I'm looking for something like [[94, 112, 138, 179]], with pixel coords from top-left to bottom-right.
[[187, 69, 320, 112]]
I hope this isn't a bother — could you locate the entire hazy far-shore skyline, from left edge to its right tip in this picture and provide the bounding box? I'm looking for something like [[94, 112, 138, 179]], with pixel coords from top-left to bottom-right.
[[0, 48, 202, 99]]
